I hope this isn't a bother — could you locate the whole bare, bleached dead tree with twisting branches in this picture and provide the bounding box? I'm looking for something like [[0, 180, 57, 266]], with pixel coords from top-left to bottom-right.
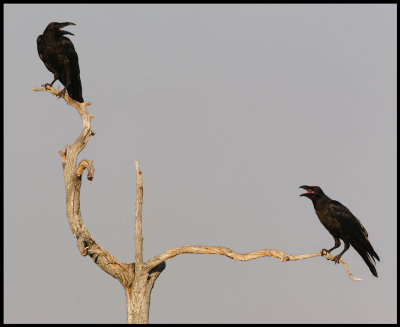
[[33, 87, 361, 324]]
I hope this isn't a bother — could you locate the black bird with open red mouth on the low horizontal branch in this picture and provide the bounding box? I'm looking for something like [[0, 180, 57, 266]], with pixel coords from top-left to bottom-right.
[[300, 185, 380, 277]]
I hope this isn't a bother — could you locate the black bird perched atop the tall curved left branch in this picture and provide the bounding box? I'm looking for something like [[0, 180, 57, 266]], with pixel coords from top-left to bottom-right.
[[36, 22, 83, 102]]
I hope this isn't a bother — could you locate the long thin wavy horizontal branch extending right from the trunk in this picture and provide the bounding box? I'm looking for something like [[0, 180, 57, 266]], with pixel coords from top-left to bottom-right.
[[143, 245, 361, 282]]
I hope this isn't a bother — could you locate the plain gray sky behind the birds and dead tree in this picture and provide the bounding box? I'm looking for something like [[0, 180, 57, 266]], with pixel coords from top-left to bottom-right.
[[4, 4, 397, 323]]
